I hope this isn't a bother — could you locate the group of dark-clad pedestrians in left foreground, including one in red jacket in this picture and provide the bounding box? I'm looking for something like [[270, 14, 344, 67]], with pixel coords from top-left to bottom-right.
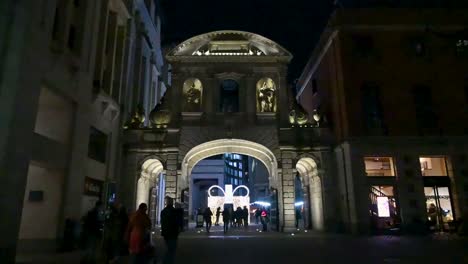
[[81, 197, 183, 264]]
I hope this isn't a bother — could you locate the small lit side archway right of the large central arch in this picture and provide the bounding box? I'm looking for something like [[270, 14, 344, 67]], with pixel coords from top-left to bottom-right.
[[296, 157, 324, 230]]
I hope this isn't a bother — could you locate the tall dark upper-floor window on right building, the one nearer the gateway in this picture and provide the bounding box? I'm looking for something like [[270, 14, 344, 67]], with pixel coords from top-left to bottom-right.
[[361, 84, 385, 133]]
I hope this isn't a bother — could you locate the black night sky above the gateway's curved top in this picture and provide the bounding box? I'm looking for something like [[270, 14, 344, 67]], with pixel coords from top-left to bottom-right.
[[162, 0, 332, 79]]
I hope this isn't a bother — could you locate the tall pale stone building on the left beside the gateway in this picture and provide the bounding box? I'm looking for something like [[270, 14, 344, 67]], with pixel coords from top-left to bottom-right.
[[0, 0, 167, 263]]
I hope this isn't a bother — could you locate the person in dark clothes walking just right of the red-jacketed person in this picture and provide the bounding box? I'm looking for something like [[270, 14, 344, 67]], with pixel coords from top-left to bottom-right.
[[161, 197, 181, 264]]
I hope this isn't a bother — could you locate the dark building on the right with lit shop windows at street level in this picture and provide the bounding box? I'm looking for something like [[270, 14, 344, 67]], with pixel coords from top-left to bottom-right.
[[297, 9, 468, 232]]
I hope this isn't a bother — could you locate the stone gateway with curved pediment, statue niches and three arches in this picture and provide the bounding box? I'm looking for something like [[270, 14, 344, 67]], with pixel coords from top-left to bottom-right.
[[120, 31, 335, 233]]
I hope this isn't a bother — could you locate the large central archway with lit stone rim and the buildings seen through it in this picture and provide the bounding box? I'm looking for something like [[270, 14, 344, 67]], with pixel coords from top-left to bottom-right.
[[179, 139, 282, 230]]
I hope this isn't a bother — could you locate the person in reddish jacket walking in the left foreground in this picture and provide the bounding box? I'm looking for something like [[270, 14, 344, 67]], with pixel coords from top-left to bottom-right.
[[126, 203, 153, 264]]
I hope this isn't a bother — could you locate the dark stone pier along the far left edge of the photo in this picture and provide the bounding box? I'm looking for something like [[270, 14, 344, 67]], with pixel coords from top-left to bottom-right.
[[0, 0, 44, 263]]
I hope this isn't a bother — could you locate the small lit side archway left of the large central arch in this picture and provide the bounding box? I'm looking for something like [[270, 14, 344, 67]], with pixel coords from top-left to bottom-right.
[[136, 159, 165, 225]]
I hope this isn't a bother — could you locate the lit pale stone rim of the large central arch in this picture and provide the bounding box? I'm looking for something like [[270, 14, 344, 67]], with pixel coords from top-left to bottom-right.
[[179, 139, 282, 225]]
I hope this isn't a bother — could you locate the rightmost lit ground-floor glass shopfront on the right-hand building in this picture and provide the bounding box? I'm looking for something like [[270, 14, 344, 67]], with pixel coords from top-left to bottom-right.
[[424, 186, 454, 231]]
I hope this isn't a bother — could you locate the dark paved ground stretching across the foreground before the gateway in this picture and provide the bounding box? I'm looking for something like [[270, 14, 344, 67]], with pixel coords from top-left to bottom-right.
[[18, 227, 468, 264]]
